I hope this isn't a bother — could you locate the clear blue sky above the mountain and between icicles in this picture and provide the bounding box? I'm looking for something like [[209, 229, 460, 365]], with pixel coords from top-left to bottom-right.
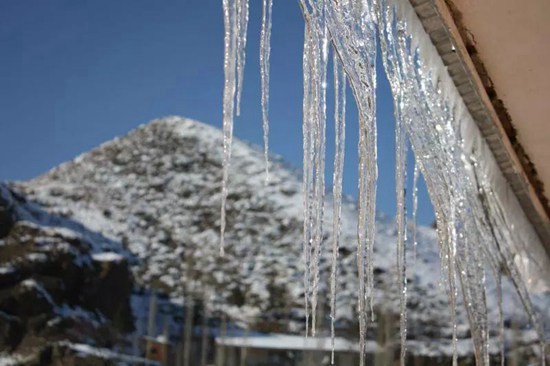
[[0, 0, 433, 224]]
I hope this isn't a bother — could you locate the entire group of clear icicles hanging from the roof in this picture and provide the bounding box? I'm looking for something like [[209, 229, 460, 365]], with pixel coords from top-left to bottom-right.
[[220, 0, 544, 365]]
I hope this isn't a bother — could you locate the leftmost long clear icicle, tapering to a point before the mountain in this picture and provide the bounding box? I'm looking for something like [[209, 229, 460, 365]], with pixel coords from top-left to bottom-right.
[[220, 0, 237, 256]]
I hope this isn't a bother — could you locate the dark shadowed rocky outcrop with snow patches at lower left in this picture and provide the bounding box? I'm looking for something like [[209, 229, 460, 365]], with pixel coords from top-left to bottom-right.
[[0, 184, 133, 358]]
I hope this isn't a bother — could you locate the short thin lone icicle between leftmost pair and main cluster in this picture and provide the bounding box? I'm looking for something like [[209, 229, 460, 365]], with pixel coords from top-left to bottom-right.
[[260, 0, 273, 185]]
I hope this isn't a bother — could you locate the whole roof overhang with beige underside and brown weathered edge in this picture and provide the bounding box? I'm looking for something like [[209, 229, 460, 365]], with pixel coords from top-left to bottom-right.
[[410, 0, 550, 257]]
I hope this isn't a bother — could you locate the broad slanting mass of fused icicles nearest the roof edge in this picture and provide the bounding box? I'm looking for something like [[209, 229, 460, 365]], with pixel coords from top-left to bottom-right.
[[380, 0, 506, 365]]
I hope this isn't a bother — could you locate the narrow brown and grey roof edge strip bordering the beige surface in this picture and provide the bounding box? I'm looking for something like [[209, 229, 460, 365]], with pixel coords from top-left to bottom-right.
[[409, 0, 550, 252]]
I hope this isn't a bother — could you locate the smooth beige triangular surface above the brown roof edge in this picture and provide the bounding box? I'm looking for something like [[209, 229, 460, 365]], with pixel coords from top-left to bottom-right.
[[451, 0, 550, 198]]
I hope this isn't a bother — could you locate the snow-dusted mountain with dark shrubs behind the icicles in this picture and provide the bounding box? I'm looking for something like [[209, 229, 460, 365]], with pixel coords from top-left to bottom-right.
[[5, 117, 548, 360]]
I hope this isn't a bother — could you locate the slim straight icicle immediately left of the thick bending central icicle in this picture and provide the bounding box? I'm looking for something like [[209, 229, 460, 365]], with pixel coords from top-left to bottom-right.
[[330, 55, 346, 365]]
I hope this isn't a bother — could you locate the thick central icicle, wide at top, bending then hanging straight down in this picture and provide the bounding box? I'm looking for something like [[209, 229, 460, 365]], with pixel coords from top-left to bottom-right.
[[327, 0, 378, 365]]
